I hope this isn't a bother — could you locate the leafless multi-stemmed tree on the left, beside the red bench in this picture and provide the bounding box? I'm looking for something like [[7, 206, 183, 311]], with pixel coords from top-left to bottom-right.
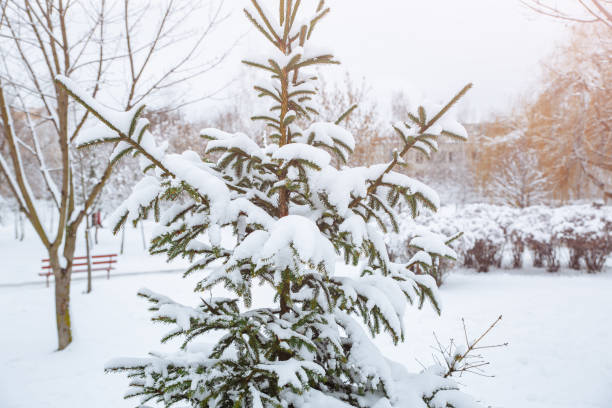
[[0, 0, 232, 350]]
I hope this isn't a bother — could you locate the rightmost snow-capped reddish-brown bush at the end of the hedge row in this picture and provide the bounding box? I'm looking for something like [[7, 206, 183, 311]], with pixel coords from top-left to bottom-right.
[[553, 205, 612, 272]]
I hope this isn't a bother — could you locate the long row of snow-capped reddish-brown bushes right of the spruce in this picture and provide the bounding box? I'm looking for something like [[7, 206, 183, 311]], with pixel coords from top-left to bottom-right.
[[387, 204, 612, 282]]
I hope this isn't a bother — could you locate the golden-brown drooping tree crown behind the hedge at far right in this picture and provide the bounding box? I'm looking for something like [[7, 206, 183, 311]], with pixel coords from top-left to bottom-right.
[[529, 25, 612, 199]]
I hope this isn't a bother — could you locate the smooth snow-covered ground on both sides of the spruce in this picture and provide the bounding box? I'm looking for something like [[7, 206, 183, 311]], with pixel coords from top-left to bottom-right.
[[0, 272, 612, 408]]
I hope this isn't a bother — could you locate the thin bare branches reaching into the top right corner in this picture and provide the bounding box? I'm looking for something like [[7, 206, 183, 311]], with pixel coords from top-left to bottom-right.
[[521, 0, 612, 28]]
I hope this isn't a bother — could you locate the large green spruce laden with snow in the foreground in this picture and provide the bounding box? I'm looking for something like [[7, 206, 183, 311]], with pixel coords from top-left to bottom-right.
[[58, 0, 474, 408]]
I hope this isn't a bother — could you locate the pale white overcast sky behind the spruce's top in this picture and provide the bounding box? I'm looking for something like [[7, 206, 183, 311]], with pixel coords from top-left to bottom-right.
[[188, 0, 569, 119]]
